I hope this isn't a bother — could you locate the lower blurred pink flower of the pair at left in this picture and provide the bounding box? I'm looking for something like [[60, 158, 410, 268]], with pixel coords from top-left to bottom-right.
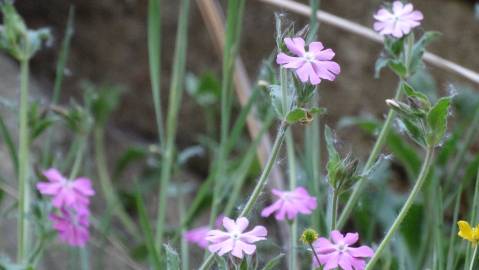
[[50, 208, 90, 247]]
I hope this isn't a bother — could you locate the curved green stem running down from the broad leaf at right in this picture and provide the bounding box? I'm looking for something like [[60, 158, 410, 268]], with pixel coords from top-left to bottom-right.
[[366, 147, 434, 270]]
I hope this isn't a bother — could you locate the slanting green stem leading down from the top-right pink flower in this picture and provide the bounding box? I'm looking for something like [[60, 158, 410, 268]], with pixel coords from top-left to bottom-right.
[[337, 79, 403, 228]]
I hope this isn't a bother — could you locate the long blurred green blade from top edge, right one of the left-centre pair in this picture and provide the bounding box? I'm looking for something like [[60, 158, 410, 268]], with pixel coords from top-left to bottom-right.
[[155, 0, 190, 250]]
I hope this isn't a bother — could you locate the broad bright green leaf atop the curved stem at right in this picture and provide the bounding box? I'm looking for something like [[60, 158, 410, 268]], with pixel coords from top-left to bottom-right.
[[427, 97, 451, 146]]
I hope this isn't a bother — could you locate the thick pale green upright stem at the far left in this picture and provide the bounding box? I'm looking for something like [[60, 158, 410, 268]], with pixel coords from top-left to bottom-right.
[[17, 59, 30, 263]]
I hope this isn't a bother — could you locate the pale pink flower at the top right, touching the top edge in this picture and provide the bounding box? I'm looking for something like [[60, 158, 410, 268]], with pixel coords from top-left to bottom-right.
[[374, 1, 423, 38]]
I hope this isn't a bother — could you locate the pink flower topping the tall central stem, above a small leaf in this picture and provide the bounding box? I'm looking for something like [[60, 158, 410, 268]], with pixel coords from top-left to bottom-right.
[[276, 37, 341, 85]]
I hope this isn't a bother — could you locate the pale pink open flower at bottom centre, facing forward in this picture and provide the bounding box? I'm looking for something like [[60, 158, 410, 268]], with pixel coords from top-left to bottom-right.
[[206, 217, 268, 259]]
